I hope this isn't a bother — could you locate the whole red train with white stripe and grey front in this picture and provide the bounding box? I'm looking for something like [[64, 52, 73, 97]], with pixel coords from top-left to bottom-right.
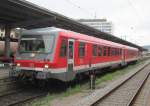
[[10, 27, 140, 81]]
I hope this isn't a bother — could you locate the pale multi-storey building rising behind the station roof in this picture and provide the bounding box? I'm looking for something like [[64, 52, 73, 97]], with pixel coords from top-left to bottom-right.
[[77, 19, 113, 34]]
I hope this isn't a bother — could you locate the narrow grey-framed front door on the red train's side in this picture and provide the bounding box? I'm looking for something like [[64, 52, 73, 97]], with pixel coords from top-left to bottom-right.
[[67, 39, 74, 71]]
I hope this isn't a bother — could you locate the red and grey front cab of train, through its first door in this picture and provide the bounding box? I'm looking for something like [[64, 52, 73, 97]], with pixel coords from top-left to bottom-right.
[[10, 28, 75, 81]]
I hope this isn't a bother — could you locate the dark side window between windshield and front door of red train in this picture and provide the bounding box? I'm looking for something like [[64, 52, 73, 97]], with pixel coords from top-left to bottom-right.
[[60, 39, 67, 57]]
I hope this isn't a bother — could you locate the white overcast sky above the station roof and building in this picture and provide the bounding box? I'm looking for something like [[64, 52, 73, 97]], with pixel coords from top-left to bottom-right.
[[28, 0, 150, 45]]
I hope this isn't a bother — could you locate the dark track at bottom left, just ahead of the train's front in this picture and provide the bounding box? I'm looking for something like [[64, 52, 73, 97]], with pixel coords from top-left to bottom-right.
[[0, 88, 47, 106]]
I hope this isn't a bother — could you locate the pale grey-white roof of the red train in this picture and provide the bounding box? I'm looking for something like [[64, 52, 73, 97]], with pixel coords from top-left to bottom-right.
[[22, 27, 137, 50]]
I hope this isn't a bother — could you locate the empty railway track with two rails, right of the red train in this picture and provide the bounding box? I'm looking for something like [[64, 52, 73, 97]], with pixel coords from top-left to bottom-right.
[[90, 64, 150, 106]]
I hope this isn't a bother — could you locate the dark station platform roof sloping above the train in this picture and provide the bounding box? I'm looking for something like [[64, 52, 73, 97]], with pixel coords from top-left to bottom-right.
[[0, 0, 145, 50]]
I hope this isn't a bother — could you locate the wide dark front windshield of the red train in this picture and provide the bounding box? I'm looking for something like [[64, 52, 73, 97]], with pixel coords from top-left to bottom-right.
[[19, 35, 54, 53]]
